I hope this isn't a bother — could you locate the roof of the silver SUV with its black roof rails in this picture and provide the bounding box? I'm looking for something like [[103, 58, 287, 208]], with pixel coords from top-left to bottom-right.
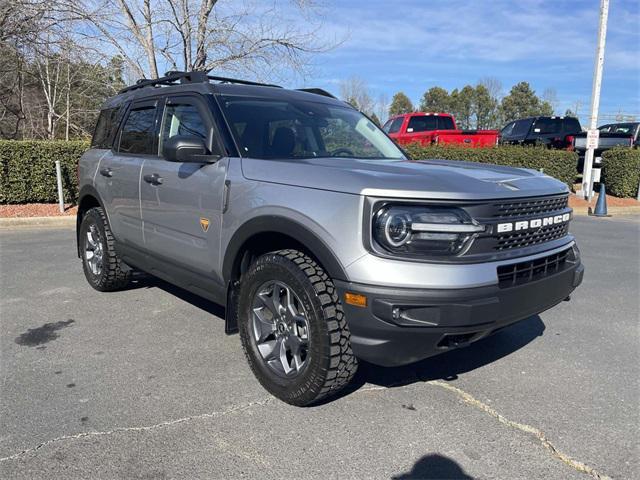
[[103, 72, 344, 108]]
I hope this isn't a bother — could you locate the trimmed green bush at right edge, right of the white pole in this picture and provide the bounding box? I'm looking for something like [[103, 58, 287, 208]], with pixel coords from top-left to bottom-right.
[[600, 147, 640, 197]]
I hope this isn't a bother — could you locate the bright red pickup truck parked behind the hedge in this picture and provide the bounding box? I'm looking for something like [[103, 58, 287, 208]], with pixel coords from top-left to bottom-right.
[[382, 112, 499, 147]]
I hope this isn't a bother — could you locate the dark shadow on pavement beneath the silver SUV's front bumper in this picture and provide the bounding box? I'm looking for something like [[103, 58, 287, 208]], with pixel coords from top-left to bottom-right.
[[334, 315, 545, 398]]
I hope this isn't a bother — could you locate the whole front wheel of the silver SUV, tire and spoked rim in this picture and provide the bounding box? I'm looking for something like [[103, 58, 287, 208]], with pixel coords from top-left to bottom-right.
[[239, 250, 358, 406]]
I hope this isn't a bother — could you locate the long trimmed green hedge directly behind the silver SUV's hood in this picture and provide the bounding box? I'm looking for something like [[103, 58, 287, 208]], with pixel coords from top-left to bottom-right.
[[405, 143, 578, 188]]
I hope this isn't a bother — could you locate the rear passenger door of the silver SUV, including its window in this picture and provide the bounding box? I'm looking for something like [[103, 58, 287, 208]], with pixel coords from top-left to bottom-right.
[[95, 100, 158, 247]]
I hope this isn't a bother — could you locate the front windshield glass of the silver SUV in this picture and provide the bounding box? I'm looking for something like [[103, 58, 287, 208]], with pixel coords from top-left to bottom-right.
[[220, 95, 404, 159]]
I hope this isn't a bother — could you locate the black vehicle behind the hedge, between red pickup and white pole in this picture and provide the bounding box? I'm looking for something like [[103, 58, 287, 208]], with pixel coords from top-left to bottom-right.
[[499, 117, 582, 149]]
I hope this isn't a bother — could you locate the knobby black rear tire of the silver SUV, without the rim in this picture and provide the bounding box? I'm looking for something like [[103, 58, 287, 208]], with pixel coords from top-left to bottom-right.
[[78, 207, 131, 292]]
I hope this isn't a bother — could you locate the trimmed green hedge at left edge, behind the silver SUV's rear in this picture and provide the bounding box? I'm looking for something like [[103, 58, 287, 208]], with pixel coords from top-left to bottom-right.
[[0, 140, 89, 204]]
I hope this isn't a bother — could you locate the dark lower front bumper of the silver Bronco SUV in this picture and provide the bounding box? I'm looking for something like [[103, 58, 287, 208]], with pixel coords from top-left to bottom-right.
[[335, 251, 584, 367]]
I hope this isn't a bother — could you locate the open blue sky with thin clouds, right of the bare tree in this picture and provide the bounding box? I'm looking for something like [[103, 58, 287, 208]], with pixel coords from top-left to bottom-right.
[[296, 0, 640, 124]]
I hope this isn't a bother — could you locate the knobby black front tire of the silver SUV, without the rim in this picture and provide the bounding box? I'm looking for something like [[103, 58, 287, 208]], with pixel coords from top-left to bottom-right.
[[238, 250, 358, 406]]
